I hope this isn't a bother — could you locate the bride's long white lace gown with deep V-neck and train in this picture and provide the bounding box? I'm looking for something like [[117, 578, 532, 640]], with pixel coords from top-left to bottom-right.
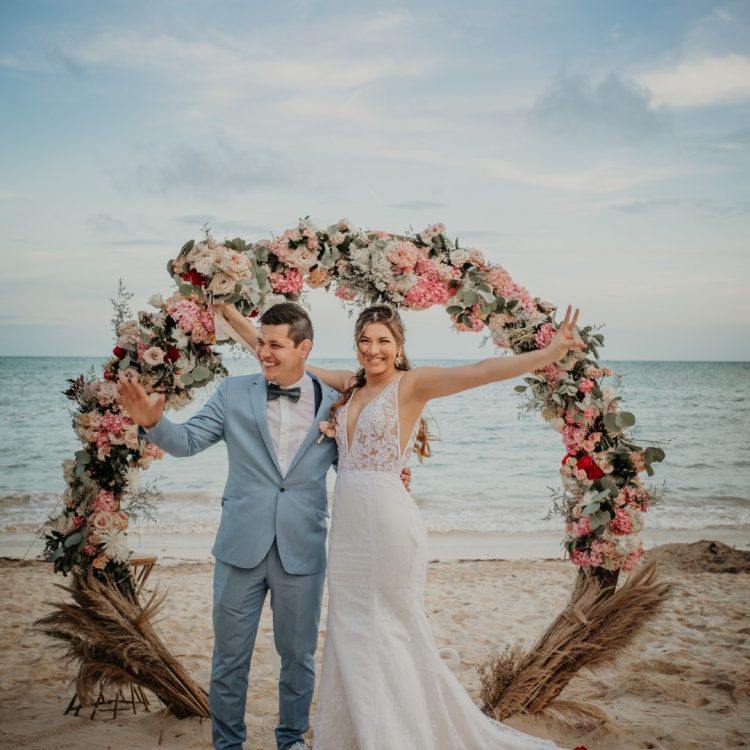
[[313, 376, 557, 750]]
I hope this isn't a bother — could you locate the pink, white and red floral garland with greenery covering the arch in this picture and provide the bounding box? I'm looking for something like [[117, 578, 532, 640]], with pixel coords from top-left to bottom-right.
[[45, 219, 664, 575]]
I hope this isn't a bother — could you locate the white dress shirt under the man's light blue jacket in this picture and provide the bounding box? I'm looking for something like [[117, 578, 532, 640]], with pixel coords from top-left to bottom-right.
[[266, 373, 315, 476]]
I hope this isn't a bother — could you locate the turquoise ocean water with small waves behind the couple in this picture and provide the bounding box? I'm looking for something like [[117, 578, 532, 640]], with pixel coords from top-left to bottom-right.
[[0, 353, 750, 534]]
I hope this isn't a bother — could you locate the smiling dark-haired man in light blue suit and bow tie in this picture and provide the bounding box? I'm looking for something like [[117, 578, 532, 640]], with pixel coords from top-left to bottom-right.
[[120, 302, 339, 750]]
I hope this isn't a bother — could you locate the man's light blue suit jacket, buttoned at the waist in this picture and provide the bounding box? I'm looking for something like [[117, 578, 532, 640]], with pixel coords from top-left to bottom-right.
[[144, 374, 339, 575]]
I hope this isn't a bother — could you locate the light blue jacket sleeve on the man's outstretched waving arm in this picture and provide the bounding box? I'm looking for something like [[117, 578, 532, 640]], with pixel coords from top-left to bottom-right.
[[138, 378, 227, 456]]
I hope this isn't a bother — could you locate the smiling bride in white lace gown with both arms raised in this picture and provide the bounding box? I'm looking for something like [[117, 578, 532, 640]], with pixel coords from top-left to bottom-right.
[[221, 305, 584, 750]]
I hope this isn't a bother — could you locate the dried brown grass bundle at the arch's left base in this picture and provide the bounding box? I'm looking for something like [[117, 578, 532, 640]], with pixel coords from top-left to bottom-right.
[[34, 572, 209, 718]]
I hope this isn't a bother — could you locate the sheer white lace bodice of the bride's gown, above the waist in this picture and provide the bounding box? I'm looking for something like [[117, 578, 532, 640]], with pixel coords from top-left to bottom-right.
[[336, 375, 419, 473]]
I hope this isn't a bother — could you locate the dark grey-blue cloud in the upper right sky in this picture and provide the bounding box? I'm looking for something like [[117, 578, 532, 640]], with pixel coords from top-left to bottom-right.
[[529, 73, 669, 140]]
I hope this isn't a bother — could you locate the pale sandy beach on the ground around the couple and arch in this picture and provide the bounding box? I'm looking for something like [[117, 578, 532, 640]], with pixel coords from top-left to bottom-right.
[[0, 529, 750, 750]]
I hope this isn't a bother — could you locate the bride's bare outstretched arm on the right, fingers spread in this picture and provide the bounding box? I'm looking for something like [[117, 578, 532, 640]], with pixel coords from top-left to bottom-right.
[[404, 306, 586, 403]]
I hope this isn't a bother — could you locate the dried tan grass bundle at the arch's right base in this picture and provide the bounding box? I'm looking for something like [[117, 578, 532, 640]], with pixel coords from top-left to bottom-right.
[[479, 562, 672, 721]]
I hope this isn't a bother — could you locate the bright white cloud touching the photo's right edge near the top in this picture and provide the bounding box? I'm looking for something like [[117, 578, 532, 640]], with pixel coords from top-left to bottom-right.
[[638, 54, 750, 108]]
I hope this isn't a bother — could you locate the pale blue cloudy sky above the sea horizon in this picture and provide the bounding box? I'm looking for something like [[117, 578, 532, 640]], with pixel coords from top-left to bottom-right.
[[0, 0, 750, 360]]
